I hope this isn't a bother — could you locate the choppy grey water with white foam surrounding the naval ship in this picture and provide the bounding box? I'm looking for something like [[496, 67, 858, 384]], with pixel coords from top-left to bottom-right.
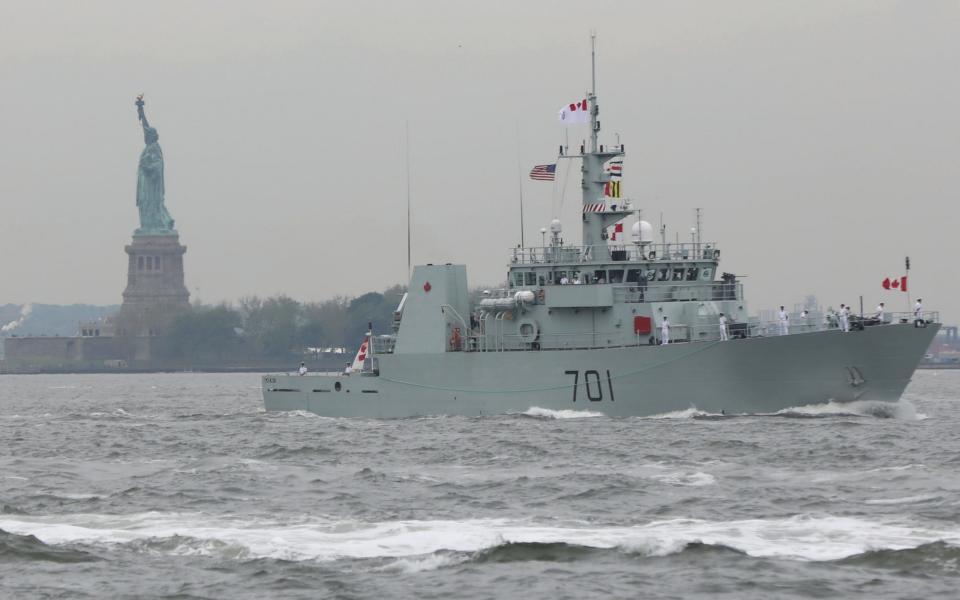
[[0, 371, 960, 600]]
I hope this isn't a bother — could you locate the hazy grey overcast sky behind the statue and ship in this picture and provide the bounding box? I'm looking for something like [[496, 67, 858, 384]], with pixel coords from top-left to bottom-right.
[[0, 0, 960, 319]]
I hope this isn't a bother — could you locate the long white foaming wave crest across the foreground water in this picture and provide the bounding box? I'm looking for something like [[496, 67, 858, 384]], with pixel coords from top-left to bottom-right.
[[0, 512, 960, 568]]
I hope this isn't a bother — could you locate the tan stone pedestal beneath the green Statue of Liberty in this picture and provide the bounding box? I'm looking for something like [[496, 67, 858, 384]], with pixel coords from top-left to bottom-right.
[[119, 232, 190, 336]]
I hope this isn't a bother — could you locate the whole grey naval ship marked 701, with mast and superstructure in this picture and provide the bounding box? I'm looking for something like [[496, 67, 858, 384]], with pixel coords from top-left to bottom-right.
[[262, 56, 940, 418]]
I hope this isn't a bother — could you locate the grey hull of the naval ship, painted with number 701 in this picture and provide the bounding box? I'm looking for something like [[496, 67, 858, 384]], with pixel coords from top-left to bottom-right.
[[263, 323, 939, 418]]
